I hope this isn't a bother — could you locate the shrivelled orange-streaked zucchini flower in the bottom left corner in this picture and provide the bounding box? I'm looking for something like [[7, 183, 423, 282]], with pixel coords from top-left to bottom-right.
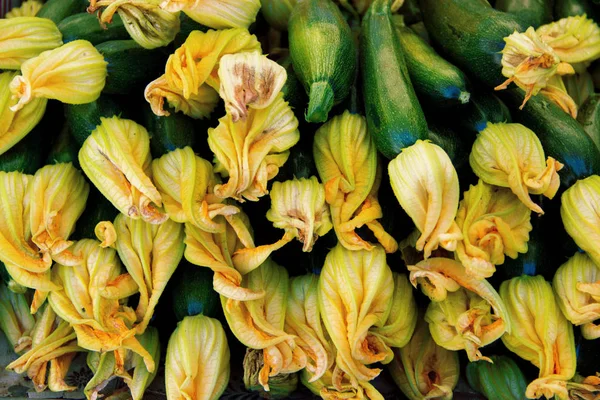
[[6, 305, 86, 392]]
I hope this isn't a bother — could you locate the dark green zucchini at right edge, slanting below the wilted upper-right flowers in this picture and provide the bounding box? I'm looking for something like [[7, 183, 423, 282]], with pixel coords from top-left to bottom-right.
[[499, 88, 600, 188]]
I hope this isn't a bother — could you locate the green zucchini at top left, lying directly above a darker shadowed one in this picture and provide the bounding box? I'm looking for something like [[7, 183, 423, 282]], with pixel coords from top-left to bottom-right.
[[58, 12, 129, 46]]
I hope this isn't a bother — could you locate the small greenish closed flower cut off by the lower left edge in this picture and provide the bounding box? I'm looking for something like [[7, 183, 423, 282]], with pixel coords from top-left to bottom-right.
[[0, 282, 35, 353]]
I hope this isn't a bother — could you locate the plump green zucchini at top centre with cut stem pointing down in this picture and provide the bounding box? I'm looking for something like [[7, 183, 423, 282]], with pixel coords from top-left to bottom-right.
[[289, 0, 357, 122]]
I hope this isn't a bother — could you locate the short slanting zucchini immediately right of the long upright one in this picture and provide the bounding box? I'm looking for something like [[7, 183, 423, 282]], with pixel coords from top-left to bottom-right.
[[397, 26, 471, 107]]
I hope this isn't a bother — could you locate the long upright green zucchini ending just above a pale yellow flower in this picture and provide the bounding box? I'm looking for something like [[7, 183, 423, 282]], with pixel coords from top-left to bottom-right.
[[360, 0, 428, 159]]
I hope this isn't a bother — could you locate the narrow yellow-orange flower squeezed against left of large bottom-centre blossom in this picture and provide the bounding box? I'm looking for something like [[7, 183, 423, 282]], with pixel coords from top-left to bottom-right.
[[285, 274, 334, 382]]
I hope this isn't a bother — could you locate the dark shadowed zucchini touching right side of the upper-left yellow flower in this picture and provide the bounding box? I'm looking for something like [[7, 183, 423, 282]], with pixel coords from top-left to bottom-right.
[[96, 40, 169, 94]]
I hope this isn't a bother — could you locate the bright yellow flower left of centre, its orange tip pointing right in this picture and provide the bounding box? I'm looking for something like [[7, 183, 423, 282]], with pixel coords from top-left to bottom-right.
[[152, 146, 239, 233]]
